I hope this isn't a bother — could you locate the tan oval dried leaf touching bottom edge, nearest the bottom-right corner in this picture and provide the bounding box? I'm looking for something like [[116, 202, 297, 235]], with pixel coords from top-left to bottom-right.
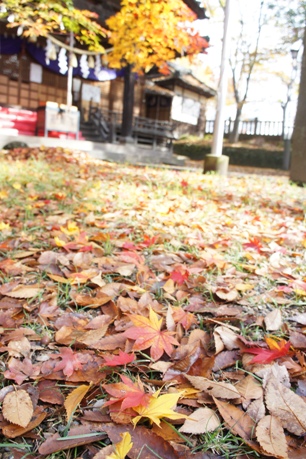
[[256, 416, 288, 459]]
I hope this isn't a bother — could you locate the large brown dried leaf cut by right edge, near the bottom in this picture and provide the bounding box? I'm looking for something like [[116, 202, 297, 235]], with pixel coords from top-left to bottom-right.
[[265, 376, 306, 435]]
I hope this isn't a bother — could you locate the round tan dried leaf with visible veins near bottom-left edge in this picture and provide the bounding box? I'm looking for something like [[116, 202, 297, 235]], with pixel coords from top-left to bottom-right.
[[2, 389, 34, 427]]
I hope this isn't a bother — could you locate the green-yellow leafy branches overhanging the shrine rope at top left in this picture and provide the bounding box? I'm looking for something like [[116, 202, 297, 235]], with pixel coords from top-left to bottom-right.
[[0, 0, 107, 53]]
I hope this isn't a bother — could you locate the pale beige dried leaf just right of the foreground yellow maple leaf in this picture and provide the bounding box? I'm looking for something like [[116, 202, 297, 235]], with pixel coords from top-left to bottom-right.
[[179, 407, 221, 434]]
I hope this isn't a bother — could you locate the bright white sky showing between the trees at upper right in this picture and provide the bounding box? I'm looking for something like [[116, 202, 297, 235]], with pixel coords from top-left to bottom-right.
[[197, 0, 301, 124]]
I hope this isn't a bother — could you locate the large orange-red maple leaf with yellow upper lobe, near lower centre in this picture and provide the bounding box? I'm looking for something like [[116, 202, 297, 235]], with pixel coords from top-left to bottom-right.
[[124, 308, 179, 360]]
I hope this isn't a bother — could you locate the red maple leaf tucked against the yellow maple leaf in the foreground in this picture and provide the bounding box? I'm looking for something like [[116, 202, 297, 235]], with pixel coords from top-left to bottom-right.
[[103, 375, 151, 411]]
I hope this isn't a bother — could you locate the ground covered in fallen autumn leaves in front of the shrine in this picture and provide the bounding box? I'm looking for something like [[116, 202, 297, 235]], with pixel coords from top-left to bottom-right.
[[0, 149, 306, 459]]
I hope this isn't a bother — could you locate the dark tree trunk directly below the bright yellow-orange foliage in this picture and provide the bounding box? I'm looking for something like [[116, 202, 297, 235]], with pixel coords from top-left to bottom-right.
[[121, 65, 135, 142]]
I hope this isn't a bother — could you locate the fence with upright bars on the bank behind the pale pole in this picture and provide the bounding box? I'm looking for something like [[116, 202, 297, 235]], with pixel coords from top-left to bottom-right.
[[205, 118, 293, 137]]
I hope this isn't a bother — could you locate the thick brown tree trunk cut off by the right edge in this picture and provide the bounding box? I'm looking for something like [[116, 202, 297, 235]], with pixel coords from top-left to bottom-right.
[[290, 28, 306, 183]]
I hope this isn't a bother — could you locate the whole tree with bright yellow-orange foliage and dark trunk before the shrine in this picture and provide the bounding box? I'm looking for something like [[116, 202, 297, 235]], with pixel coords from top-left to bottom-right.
[[106, 0, 208, 138]]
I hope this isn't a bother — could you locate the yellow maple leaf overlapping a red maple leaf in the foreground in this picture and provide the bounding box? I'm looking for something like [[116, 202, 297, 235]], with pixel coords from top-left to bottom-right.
[[133, 392, 187, 427]]
